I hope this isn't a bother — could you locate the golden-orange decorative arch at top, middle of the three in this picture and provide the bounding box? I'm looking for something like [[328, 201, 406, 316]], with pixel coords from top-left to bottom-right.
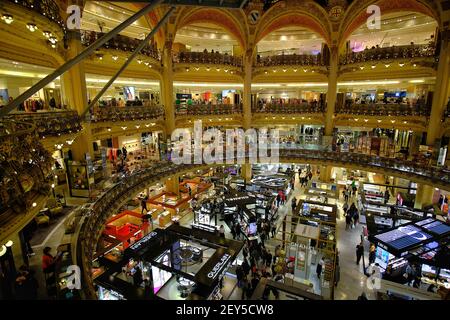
[[256, 0, 331, 44]]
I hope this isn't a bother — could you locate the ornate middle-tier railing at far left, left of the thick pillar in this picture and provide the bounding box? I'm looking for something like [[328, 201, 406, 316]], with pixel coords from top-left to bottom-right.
[[5, 110, 82, 137]]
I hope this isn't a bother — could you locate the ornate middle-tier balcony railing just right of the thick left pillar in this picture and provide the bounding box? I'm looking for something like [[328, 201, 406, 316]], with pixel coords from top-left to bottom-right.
[[91, 107, 165, 122]]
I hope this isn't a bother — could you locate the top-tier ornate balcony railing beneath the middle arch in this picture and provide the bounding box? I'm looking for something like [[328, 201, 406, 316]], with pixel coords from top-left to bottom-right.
[[255, 54, 327, 67]]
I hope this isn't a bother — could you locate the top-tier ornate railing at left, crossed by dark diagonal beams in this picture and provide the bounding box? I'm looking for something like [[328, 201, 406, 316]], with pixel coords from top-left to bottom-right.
[[81, 30, 161, 61]]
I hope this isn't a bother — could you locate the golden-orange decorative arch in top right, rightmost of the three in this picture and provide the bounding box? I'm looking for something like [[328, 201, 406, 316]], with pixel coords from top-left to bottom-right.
[[339, 0, 441, 46]]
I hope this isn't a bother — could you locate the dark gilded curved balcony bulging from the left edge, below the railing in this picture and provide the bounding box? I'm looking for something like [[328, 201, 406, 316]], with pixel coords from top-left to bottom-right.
[[0, 117, 53, 243]]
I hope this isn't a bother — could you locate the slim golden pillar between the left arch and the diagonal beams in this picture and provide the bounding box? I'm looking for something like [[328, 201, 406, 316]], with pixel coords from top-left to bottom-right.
[[161, 41, 175, 137]]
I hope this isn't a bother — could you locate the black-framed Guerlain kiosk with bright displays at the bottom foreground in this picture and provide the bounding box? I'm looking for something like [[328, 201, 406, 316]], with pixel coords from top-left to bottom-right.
[[95, 225, 243, 300]]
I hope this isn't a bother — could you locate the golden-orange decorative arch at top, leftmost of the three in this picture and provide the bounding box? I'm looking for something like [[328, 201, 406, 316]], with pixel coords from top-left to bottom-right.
[[175, 8, 247, 49]]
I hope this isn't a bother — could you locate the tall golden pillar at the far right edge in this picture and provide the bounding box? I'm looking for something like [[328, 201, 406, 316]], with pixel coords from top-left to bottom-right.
[[427, 33, 450, 146]]
